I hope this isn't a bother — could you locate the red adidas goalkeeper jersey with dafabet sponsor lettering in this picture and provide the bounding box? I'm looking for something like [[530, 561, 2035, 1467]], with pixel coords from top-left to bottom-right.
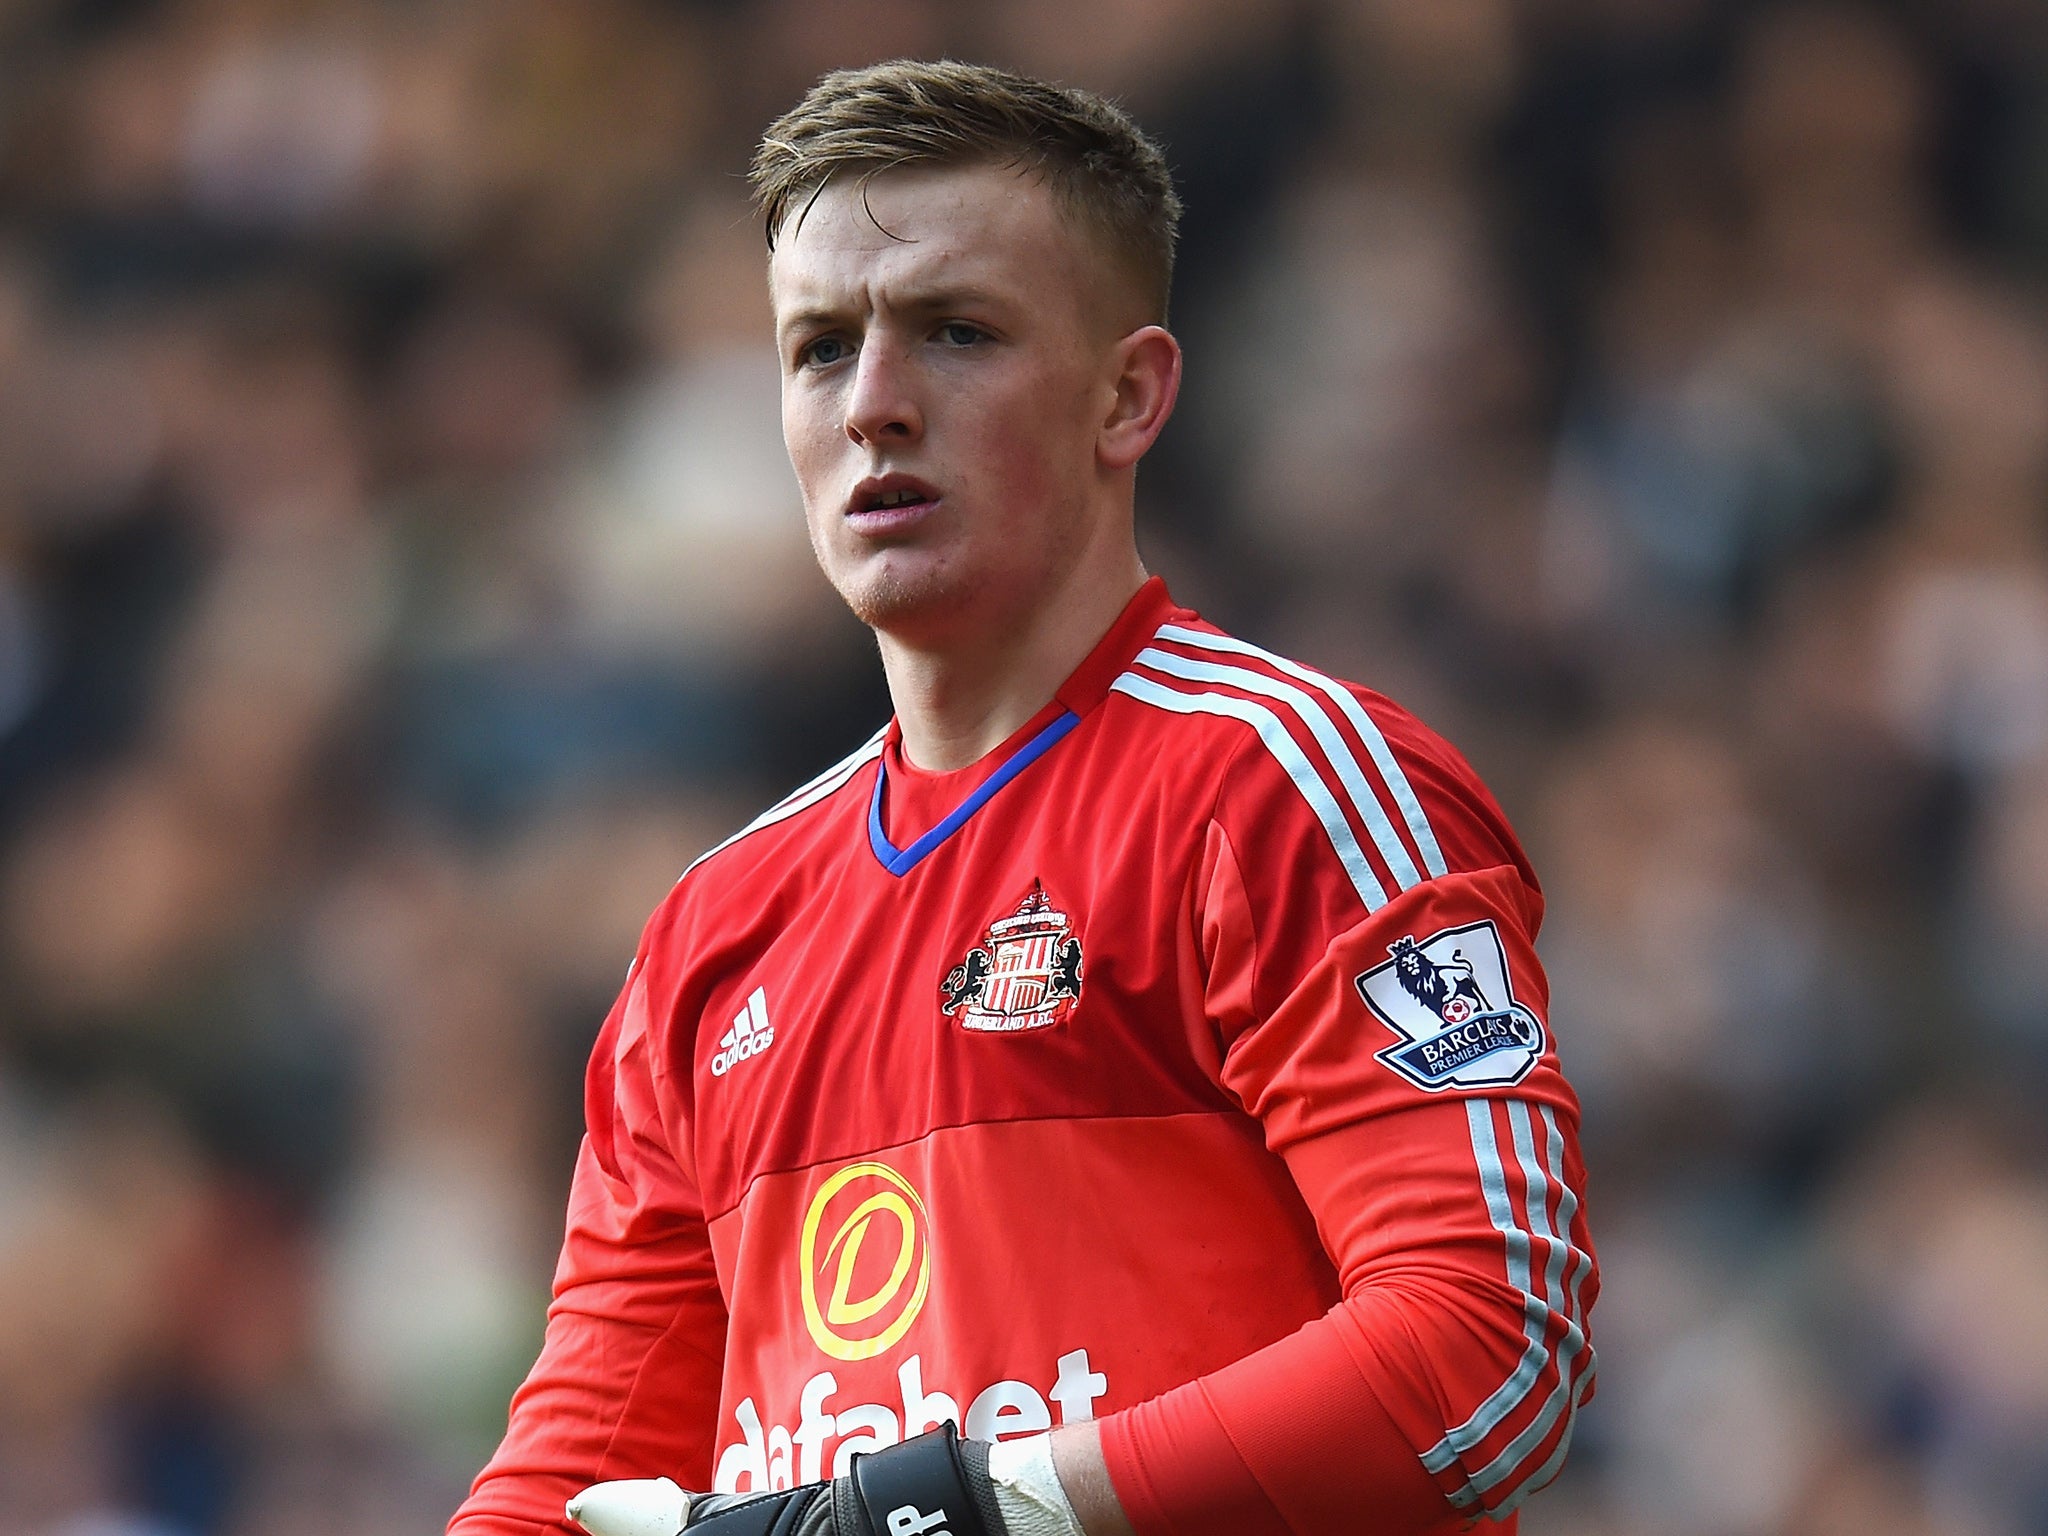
[[453, 582, 1599, 1536]]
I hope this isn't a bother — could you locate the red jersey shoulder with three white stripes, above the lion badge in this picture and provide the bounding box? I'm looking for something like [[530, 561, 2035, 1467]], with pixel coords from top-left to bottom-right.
[[1114, 623, 1536, 911]]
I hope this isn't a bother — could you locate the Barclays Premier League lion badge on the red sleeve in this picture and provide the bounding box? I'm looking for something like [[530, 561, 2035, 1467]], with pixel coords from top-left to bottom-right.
[[1356, 922, 1544, 1094]]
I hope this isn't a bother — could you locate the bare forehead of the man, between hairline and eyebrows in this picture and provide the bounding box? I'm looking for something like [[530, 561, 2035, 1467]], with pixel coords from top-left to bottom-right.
[[768, 166, 1085, 313]]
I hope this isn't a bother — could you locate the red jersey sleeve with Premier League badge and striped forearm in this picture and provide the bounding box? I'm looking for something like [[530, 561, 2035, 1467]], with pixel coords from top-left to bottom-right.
[[1104, 708, 1599, 1536]]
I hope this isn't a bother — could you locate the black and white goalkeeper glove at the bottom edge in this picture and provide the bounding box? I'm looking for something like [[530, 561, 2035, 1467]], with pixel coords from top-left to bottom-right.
[[569, 1423, 1008, 1536]]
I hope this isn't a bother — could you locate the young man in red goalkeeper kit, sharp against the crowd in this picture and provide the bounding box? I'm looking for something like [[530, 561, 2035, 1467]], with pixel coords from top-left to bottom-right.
[[453, 63, 1597, 1536]]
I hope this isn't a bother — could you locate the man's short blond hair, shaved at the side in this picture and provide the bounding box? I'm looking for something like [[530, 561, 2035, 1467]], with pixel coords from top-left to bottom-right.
[[750, 59, 1180, 324]]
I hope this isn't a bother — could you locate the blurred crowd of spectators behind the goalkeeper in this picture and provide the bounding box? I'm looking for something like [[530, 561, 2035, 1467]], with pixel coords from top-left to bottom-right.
[[0, 0, 2048, 1536]]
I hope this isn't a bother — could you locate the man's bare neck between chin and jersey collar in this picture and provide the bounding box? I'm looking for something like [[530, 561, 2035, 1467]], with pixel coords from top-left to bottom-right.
[[877, 551, 1145, 772]]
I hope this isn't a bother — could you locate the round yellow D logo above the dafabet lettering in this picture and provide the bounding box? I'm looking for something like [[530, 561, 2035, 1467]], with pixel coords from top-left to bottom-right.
[[801, 1163, 932, 1360]]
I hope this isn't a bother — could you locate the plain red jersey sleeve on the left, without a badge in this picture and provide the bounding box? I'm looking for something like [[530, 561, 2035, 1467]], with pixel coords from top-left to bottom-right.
[[449, 913, 725, 1536]]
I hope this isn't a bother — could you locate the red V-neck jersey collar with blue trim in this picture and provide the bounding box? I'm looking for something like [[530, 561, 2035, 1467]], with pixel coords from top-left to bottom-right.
[[868, 575, 1192, 879]]
